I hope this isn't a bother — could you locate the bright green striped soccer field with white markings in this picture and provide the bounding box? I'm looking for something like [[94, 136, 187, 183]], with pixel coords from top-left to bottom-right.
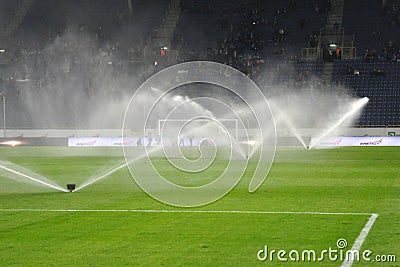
[[0, 147, 400, 266]]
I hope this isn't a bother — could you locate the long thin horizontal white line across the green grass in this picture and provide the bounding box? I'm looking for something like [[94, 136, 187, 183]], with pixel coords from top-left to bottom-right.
[[0, 209, 378, 216]]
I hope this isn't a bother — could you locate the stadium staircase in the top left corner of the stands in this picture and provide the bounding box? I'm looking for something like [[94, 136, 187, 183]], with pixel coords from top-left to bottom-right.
[[0, 0, 34, 64]]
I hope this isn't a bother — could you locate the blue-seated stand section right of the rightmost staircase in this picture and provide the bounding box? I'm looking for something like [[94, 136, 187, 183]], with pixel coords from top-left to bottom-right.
[[333, 0, 400, 127]]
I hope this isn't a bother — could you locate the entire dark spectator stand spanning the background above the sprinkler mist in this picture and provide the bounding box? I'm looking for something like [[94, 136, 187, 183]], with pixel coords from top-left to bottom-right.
[[0, 0, 400, 127]]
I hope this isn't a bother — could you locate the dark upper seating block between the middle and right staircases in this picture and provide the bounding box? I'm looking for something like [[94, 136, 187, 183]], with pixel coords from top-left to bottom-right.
[[175, 0, 326, 71]]
